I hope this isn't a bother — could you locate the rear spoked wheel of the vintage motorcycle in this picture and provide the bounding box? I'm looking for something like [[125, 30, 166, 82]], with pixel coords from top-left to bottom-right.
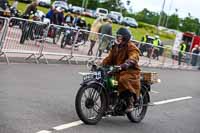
[[127, 91, 148, 123]]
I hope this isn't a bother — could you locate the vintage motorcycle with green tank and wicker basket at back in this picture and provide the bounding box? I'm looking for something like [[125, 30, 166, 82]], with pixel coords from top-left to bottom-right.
[[75, 65, 160, 125]]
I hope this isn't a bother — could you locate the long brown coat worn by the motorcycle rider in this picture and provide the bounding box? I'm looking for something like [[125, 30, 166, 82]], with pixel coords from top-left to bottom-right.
[[103, 42, 141, 96]]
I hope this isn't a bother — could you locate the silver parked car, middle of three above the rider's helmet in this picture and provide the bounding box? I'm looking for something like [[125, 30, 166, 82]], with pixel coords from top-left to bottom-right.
[[108, 11, 123, 24]]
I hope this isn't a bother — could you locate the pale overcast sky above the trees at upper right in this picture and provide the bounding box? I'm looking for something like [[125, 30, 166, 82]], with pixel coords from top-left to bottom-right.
[[122, 0, 200, 19]]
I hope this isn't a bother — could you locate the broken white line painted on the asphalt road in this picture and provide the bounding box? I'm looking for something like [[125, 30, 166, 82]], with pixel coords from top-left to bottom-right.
[[36, 96, 192, 133]]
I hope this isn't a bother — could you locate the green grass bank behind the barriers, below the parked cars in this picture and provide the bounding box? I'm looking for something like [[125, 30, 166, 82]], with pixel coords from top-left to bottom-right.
[[9, 0, 175, 40]]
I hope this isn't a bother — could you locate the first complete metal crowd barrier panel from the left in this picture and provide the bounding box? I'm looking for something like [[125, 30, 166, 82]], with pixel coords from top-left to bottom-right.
[[2, 18, 48, 63]]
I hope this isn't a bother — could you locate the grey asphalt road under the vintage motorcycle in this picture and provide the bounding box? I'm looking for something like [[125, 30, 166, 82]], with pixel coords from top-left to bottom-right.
[[0, 64, 200, 133]]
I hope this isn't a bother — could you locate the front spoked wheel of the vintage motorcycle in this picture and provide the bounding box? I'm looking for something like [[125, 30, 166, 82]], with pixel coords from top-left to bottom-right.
[[76, 84, 106, 125]]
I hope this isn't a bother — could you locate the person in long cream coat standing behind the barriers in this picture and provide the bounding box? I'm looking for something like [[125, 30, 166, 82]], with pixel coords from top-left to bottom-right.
[[88, 17, 103, 55]]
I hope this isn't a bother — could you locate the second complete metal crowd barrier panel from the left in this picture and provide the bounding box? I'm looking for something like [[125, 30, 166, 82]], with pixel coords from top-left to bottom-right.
[[38, 24, 74, 63]]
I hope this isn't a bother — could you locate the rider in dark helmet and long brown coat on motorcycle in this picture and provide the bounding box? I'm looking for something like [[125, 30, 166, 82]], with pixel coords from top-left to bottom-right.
[[102, 28, 140, 112]]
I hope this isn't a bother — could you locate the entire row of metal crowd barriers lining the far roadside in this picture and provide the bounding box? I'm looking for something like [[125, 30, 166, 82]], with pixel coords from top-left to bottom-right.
[[0, 17, 200, 68]]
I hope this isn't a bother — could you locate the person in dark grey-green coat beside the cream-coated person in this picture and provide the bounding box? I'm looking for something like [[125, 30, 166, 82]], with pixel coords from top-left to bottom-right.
[[98, 18, 112, 57]]
